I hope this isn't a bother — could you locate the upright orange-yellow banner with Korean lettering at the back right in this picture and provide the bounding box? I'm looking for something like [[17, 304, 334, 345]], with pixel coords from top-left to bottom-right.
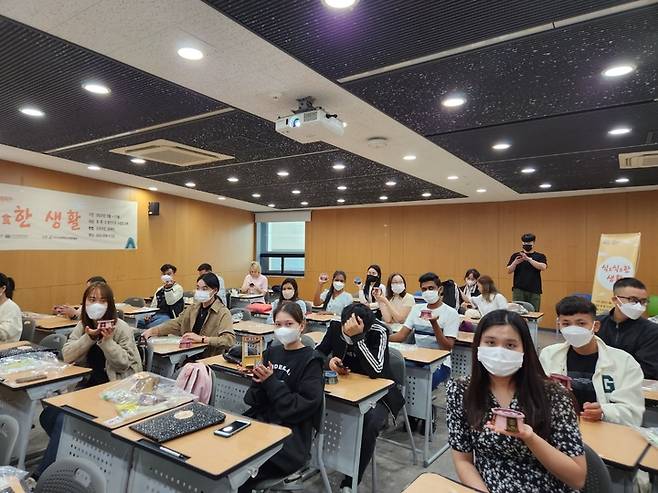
[[592, 233, 641, 313]]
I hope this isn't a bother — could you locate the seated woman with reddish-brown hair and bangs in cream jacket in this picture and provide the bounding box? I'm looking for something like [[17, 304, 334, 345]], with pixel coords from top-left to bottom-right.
[[36, 282, 142, 477]]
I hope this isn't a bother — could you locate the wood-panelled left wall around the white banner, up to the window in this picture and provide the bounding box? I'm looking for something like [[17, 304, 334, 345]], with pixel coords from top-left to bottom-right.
[[0, 161, 255, 311]]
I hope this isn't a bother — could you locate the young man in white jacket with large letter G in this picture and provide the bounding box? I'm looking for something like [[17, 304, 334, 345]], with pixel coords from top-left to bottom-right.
[[539, 296, 644, 426]]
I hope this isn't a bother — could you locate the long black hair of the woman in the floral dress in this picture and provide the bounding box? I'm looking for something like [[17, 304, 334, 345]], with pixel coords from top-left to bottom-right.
[[464, 310, 565, 440]]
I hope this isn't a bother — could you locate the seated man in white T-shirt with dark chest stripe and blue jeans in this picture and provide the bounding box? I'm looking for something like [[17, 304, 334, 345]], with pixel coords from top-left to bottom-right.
[[388, 272, 460, 388]]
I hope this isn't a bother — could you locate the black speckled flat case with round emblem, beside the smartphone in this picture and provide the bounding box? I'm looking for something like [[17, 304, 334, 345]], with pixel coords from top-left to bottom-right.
[[130, 402, 226, 443]]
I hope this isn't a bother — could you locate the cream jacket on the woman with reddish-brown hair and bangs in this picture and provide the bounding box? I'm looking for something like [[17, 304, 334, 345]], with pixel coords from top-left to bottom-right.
[[62, 320, 142, 380]]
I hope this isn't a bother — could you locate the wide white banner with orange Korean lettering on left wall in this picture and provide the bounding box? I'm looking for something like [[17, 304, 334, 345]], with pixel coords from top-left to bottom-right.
[[0, 183, 137, 250]]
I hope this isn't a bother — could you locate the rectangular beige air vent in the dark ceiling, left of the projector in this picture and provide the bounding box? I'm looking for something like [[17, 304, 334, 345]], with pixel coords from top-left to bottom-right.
[[110, 139, 234, 166]]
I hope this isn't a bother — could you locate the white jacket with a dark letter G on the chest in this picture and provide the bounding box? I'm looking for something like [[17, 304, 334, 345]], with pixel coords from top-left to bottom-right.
[[539, 336, 644, 426]]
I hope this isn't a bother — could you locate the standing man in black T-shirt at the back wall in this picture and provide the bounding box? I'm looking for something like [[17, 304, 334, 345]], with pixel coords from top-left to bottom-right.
[[507, 233, 547, 311]]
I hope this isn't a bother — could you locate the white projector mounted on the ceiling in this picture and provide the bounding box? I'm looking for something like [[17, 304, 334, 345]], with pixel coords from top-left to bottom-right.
[[275, 97, 344, 144]]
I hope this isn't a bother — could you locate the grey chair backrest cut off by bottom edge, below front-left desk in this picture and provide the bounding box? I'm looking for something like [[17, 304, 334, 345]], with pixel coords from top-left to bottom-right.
[[34, 458, 107, 493]]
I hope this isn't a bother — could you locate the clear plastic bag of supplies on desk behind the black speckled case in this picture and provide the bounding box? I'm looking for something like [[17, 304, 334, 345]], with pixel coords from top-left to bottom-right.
[[100, 371, 196, 419]]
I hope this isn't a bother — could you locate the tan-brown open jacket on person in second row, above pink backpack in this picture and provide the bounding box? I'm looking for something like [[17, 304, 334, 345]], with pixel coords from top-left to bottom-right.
[[153, 299, 235, 357]]
